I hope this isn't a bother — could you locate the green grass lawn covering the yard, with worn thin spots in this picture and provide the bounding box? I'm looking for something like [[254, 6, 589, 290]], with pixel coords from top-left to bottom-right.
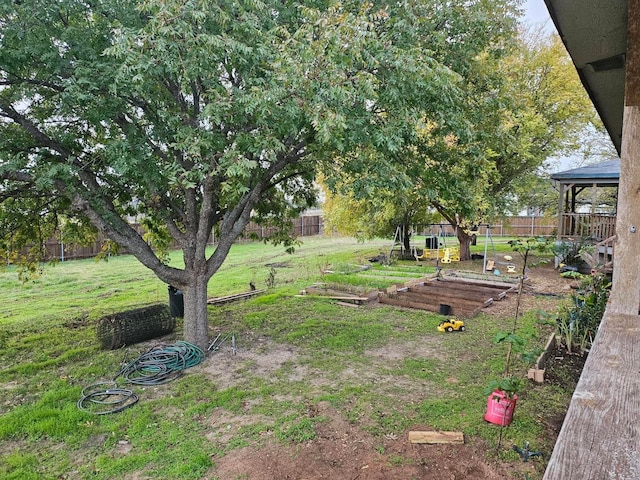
[[0, 237, 572, 479]]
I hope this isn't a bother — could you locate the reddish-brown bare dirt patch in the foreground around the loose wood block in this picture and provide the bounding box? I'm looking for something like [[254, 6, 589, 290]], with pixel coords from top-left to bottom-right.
[[212, 402, 533, 480]]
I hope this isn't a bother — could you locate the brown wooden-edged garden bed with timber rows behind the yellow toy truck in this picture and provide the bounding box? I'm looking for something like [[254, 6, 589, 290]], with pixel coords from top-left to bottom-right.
[[379, 277, 513, 317]]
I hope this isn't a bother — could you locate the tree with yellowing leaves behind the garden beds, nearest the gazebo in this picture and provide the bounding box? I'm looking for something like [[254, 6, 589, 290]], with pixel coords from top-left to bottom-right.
[[324, 29, 595, 259]]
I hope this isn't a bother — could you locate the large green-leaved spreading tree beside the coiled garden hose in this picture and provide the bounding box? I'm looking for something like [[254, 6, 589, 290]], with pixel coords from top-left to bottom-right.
[[0, 0, 462, 347]]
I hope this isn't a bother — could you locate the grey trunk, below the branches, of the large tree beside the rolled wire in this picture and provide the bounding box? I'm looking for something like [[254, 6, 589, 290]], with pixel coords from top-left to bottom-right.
[[182, 274, 209, 352]]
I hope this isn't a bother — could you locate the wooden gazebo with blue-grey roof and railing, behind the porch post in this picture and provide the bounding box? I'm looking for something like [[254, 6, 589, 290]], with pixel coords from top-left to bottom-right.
[[551, 158, 620, 243]]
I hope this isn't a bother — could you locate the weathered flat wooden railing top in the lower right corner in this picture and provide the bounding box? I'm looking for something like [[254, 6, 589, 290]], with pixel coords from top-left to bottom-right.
[[543, 313, 640, 480]]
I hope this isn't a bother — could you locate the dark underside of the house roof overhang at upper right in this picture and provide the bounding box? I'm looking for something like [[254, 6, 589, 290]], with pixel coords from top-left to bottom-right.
[[545, 0, 627, 154]]
